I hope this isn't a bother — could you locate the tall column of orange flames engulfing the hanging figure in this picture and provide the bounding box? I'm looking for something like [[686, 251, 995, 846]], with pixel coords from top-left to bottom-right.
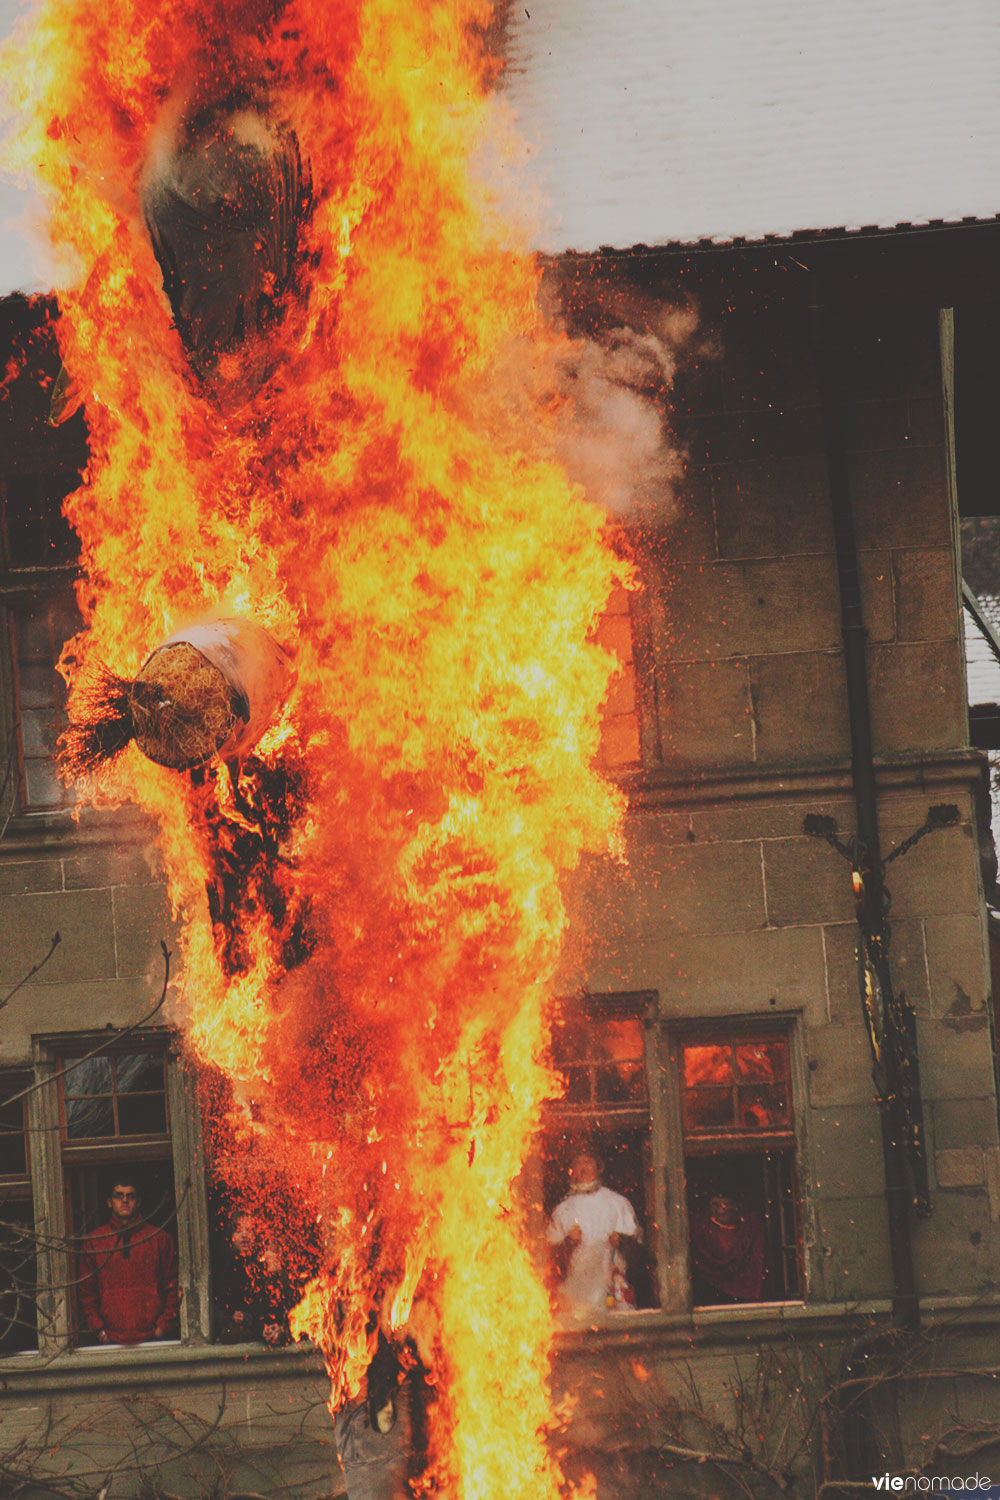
[[6, 0, 627, 1500]]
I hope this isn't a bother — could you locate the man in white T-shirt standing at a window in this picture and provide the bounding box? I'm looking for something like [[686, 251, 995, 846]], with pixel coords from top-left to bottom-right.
[[549, 1151, 640, 1317]]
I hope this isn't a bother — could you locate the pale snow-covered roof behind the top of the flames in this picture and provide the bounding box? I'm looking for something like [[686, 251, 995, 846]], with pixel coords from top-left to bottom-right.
[[0, 0, 1000, 293]]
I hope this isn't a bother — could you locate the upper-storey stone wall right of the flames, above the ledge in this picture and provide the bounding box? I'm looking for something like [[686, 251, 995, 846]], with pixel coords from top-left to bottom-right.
[[639, 298, 967, 773]]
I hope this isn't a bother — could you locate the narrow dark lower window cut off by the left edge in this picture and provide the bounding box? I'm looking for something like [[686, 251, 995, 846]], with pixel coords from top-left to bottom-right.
[[0, 1074, 37, 1356]]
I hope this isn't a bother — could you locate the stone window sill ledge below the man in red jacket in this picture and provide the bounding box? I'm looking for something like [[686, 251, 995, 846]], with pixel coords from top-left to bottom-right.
[[0, 1343, 322, 1395]]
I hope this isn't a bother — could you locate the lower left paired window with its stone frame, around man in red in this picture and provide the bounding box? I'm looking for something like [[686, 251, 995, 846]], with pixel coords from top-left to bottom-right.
[[0, 1028, 211, 1361]]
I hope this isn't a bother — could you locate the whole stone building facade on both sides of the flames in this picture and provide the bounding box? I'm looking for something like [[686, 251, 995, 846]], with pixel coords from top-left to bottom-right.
[[0, 228, 1000, 1500]]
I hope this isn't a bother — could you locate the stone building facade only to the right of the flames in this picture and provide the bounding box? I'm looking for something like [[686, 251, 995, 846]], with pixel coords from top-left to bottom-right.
[[542, 230, 1000, 1496]]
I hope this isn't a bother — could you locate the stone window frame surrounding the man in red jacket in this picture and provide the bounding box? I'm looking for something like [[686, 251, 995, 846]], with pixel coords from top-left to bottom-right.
[[28, 1028, 211, 1359]]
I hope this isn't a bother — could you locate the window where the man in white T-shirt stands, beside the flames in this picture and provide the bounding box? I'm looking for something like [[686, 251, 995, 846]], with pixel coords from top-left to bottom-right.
[[541, 995, 661, 1320]]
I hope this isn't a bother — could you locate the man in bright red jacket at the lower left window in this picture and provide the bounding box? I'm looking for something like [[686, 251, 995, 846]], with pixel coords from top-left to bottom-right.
[[79, 1176, 180, 1344]]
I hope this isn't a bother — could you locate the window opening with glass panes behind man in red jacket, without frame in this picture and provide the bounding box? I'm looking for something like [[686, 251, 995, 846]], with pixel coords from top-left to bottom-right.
[[58, 1041, 177, 1343]]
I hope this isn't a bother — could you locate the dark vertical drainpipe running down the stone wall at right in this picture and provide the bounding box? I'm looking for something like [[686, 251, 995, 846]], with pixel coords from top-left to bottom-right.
[[810, 272, 921, 1328]]
